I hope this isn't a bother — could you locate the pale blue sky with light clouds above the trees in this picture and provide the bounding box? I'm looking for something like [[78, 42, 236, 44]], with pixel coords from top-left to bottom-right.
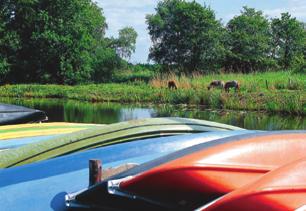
[[95, 0, 306, 63]]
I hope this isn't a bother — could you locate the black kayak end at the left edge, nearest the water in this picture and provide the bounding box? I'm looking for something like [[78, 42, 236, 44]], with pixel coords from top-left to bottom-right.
[[0, 103, 47, 125]]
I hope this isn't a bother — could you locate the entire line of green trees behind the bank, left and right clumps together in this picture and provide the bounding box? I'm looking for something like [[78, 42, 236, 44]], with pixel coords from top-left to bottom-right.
[[0, 0, 306, 84]]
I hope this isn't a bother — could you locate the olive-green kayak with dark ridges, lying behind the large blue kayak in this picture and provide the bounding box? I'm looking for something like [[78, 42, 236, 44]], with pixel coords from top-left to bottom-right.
[[0, 118, 244, 168]]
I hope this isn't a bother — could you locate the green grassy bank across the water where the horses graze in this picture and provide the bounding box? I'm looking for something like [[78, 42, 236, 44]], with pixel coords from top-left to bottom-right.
[[0, 72, 306, 115]]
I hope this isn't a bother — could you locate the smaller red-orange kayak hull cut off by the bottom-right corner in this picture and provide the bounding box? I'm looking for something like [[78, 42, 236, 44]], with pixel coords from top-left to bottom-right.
[[199, 157, 306, 211]]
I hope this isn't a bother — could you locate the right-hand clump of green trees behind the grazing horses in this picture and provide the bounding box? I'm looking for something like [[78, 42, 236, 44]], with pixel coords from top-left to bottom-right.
[[146, 0, 306, 74]]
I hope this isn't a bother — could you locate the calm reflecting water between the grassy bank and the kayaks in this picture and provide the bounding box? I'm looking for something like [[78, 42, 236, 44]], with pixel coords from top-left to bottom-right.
[[0, 98, 306, 130]]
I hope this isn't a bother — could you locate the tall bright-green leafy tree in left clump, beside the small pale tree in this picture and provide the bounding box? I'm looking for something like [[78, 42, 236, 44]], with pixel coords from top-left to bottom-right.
[[31, 0, 106, 84]]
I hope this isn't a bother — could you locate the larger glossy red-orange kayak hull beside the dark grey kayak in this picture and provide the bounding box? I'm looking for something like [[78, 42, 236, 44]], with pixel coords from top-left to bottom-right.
[[119, 132, 306, 209]]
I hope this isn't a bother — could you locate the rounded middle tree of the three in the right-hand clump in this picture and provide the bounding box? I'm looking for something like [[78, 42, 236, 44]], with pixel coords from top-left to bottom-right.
[[225, 7, 273, 73]]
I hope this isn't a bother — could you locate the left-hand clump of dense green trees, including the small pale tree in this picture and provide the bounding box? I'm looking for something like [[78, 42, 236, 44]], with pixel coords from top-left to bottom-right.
[[0, 0, 137, 84]]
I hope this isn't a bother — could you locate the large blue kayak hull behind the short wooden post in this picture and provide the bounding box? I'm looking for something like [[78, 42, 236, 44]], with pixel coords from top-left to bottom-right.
[[0, 130, 253, 210]]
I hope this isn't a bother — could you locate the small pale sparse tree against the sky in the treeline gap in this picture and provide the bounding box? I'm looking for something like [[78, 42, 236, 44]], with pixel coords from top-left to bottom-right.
[[115, 27, 137, 59]]
